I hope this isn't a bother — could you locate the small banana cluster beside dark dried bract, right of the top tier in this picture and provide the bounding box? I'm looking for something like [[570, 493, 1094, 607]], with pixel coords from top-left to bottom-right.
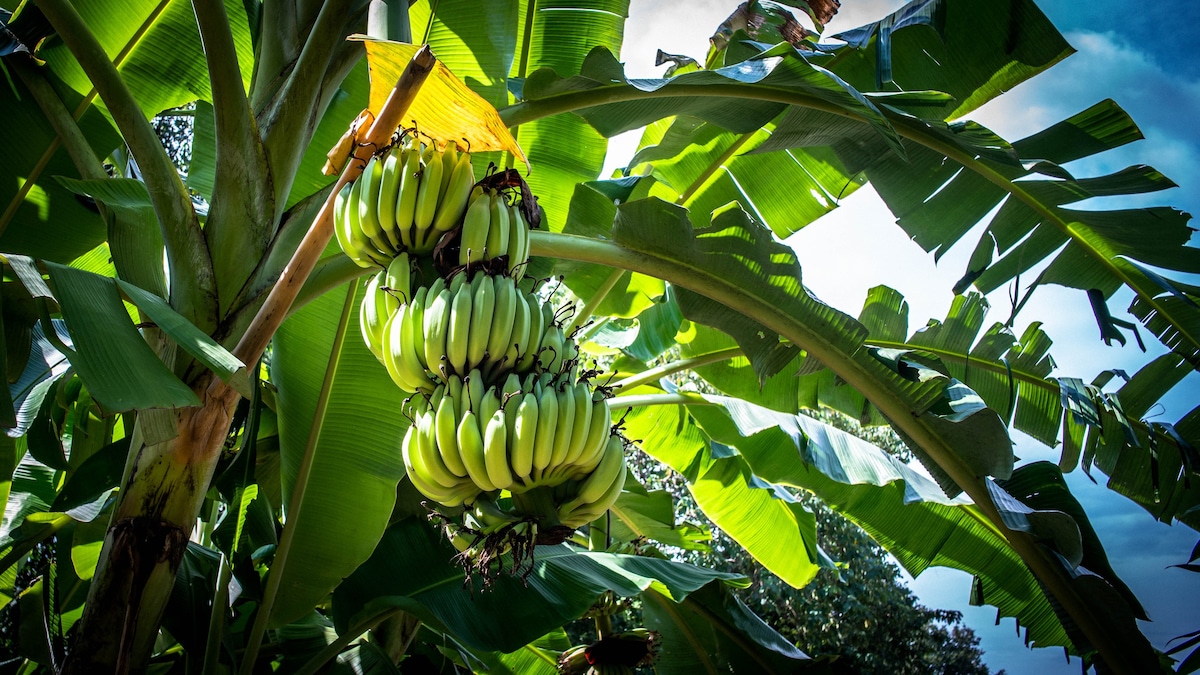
[[458, 185, 529, 276]]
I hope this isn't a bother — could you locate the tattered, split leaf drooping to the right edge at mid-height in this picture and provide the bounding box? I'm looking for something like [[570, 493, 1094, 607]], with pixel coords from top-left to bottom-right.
[[859, 281, 1200, 528]]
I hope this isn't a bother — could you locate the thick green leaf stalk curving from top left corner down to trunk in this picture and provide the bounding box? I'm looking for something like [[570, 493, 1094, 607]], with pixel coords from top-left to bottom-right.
[[37, 0, 217, 333]]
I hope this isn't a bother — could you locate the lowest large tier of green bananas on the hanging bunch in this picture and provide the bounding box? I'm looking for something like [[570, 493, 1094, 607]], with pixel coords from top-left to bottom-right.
[[402, 369, 625, 502]]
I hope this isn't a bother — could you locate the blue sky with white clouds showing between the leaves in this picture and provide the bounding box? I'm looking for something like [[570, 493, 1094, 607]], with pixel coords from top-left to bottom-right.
[[610, 0, 1200, 674]]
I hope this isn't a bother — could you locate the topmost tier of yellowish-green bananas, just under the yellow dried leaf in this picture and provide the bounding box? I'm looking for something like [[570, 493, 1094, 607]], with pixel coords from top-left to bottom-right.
[[334, 133, 475, 267]]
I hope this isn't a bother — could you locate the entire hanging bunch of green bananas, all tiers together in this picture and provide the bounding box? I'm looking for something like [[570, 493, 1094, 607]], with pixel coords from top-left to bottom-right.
[[335, 130, 626, 573]]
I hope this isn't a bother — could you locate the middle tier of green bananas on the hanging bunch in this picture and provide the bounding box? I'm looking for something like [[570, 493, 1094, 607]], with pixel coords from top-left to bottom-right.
[[379, 268, 578, 392]]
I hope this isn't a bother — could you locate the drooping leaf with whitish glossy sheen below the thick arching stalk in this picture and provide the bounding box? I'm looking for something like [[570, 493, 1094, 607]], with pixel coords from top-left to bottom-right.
[[691, 398, 1069, 646]]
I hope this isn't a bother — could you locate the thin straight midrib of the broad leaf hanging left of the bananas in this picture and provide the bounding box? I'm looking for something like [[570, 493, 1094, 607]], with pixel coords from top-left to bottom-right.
[[239, 283, 358, 675]]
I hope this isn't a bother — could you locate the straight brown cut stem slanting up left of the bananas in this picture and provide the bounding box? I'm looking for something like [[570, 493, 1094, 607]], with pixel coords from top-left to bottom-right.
[[220, 46, 437, 392]]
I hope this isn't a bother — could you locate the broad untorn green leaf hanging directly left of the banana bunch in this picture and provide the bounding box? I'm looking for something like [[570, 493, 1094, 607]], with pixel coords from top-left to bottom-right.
[[270, 281, 409, 625]]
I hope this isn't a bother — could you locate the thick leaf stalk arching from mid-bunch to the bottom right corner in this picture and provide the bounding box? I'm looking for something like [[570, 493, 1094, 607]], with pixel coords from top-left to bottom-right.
[[530, 231, 1139, 674]]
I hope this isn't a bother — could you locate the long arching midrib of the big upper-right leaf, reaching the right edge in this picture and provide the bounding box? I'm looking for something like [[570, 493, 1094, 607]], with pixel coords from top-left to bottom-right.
[[500, 83, 1200, 372]]
